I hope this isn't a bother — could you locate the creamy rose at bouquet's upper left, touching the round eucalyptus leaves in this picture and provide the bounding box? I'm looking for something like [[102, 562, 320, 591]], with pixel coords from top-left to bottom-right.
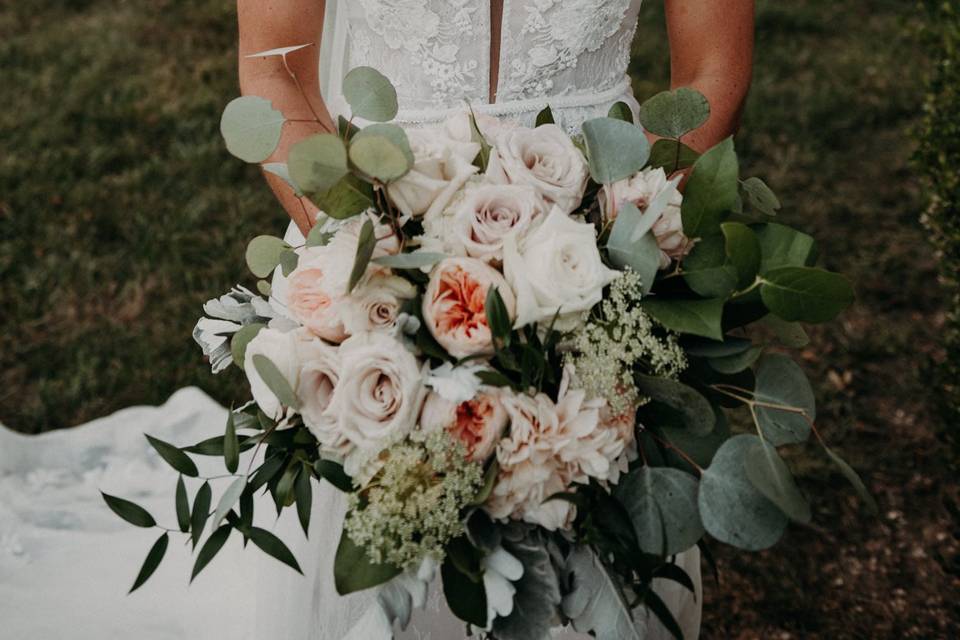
[[387, 128, 480, 216]]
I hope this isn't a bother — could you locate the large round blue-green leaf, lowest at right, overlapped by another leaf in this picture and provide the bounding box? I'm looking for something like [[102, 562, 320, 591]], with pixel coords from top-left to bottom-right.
[[697, 435, 787, 551]]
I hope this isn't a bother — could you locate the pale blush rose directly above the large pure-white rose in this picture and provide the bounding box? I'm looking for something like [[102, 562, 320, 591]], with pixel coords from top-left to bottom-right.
[[488, 124, 588, 213]]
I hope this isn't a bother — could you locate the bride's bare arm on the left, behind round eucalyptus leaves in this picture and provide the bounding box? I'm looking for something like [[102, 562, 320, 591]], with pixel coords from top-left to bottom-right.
[[237, 0, 334, 233]]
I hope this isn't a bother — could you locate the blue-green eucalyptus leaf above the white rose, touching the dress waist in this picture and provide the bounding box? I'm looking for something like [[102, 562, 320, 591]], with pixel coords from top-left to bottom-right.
[[583, 118, 650, 184]]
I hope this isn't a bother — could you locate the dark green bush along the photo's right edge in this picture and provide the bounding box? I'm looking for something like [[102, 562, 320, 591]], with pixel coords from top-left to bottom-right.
[[915, 0, 960, 418]]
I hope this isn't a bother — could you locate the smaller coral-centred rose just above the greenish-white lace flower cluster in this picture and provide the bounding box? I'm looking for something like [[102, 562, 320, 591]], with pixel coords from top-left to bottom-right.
[[420, 387, 507, 462]]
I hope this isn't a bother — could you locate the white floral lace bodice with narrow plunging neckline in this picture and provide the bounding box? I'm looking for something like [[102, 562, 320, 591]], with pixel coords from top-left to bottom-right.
[[324, 0, 642, 127]]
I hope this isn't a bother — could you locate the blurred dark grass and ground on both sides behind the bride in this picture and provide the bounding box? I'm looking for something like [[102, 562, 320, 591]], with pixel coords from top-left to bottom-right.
[[0, 0, 960, 639]]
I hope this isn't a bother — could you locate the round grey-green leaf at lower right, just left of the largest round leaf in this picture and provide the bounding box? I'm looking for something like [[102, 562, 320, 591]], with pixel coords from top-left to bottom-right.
[[616, 467, 703, 556]]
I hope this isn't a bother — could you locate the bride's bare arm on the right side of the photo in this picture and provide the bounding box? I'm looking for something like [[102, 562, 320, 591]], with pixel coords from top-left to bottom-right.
[[665, 0, 754, 151]]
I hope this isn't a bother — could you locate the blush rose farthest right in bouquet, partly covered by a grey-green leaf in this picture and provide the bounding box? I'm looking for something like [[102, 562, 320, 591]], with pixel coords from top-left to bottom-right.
[[599, 168, 693, 269]]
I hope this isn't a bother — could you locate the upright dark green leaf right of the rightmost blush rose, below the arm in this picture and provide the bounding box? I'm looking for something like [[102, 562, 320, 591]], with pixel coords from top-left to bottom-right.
[[680, 138, 740, 238]]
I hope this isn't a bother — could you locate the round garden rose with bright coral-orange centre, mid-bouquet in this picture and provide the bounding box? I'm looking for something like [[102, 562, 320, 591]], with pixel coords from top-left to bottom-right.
[[423, 258, 516, 358]]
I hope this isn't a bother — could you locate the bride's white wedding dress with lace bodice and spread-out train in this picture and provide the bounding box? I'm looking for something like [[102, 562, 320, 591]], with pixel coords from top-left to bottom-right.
[[0, 0, 701, 640]]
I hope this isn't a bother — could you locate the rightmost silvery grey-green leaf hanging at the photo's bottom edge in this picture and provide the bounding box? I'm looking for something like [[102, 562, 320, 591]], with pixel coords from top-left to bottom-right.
[[562, 545, 646, 640]]
